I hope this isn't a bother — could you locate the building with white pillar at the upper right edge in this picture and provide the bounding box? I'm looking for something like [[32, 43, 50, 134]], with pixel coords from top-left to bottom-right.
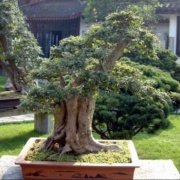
[[156, 0, 180, 56]]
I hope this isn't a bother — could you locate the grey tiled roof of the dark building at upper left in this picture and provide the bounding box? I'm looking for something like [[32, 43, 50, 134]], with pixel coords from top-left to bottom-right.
[[21, 0, 82, 20]]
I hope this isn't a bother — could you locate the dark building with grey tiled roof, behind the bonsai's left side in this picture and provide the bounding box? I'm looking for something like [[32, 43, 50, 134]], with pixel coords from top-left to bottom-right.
[[19, 0, 82, 57]]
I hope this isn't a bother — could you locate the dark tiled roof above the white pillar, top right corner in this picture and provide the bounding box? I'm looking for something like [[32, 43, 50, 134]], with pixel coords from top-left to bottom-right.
[[156, 0, 180, 14]]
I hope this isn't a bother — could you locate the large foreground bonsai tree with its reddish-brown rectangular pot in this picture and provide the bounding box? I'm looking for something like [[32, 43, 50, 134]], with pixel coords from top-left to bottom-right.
[[16, 12, 155, 179]]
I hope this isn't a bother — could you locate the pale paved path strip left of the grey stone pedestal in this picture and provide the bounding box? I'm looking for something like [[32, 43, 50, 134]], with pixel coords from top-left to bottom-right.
[[0, 114, 34, 123]]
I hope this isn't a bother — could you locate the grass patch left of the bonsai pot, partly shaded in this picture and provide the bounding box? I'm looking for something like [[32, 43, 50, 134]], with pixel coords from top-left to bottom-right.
[[0, 122, 46, 156]]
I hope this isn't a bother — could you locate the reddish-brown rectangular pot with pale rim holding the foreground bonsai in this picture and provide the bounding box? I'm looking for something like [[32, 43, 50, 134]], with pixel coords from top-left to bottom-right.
[[16, 138, 139, 180]]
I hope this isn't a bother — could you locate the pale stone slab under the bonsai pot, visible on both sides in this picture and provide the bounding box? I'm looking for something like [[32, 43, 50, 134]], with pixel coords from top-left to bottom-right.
[[0, 156, 180, 180]]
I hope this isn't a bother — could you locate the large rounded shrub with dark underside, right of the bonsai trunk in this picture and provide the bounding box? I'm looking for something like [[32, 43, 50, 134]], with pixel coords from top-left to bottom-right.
[[93, 58, 173, 139]]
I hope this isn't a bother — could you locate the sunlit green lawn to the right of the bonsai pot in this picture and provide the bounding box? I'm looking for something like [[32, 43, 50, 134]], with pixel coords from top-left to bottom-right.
[[133, 115, 180, 170]]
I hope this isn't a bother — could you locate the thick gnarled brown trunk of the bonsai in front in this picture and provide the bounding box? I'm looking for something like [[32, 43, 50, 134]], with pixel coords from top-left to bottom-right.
[[42, 96, 119, 154]]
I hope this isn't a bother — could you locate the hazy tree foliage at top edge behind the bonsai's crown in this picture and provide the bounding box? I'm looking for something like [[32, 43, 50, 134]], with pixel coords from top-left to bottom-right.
[[83, 0, 160, 25]]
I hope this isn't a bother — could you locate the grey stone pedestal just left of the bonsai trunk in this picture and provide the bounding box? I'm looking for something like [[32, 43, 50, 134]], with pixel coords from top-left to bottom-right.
[[34, 113, 54, 133]]
